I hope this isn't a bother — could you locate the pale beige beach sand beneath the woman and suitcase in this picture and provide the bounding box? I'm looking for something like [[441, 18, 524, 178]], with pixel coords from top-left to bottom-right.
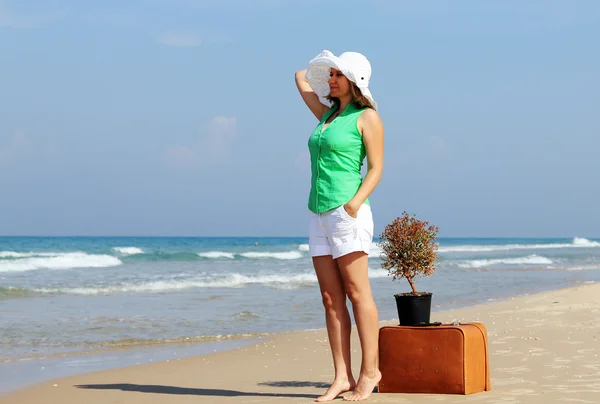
[[0, 284, 600, 404]]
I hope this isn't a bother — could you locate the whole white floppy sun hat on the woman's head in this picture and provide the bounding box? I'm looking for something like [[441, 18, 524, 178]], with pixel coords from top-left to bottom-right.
[[306, 50, 377, 109]]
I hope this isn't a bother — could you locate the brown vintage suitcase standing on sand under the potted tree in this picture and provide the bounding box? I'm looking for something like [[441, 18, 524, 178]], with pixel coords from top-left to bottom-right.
[[378, 322, 491, 394]]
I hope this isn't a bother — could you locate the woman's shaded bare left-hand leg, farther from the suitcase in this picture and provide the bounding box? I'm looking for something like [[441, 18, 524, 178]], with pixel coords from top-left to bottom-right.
[[313, 255, 356, 401]]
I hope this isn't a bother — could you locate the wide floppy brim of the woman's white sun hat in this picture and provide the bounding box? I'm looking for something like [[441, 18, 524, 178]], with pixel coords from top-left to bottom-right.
[[306, 51, 377, 110]]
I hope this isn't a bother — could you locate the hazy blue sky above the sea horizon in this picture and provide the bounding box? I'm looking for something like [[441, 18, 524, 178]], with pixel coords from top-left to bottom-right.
[[0, 0, 600, 237]]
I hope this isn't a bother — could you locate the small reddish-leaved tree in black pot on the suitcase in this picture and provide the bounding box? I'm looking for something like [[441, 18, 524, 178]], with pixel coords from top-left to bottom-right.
[[378, 212, 439, 326]]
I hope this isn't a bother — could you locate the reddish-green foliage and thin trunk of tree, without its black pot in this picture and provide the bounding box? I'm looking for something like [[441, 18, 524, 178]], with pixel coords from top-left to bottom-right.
[[378, 212, 439, 295]]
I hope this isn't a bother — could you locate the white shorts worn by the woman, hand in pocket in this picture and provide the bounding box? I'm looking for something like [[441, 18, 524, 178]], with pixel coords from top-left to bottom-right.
[[308, 204, 373, 259]]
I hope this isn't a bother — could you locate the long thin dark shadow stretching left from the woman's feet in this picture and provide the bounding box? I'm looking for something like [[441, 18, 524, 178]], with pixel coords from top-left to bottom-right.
[[75, 382, 319, 398]]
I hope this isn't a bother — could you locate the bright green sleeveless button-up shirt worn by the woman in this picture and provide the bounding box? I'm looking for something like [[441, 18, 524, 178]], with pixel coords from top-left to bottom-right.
[[308, 103, 369, 213]]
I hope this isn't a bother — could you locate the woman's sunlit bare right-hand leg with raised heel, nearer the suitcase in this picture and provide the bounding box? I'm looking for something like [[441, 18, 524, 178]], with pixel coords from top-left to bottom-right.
[[337, 252, 381, 401]]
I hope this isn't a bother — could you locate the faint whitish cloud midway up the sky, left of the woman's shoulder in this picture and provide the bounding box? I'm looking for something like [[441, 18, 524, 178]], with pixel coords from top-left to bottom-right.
[[164, 116, 238, 167]]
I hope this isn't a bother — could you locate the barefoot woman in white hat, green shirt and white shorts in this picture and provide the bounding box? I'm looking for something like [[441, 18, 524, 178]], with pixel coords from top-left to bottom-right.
[[296, 51, 383, 401]]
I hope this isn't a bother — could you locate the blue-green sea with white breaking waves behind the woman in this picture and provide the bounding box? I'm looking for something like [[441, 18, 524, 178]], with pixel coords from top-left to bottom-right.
[[0, 237, 600, 370]]
